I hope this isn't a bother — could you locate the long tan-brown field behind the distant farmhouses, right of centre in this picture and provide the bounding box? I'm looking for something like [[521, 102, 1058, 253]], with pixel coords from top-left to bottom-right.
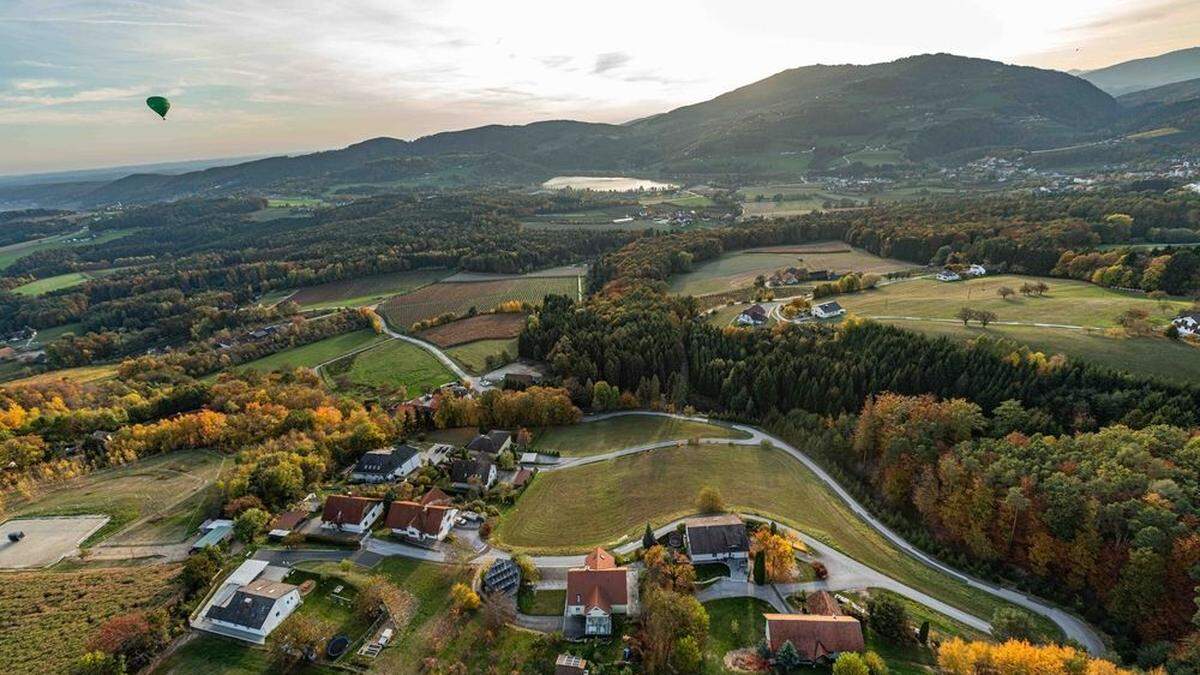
[[671, 241, 916, 295]]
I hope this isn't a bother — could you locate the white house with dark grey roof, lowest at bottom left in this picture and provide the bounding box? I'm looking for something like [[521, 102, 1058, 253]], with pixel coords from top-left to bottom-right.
[[192, 560, 302, 645]]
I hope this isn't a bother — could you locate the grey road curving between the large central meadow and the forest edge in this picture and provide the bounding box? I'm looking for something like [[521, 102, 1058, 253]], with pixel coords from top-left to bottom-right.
[[559, 411, 1105, 655]]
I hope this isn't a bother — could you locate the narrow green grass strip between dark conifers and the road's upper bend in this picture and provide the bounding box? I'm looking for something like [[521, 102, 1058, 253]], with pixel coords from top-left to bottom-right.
[[530, 414, 746, 456]]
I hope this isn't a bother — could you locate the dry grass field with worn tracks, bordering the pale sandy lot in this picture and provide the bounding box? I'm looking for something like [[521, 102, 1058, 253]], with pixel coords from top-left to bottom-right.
[[5, 450, 223, 544]]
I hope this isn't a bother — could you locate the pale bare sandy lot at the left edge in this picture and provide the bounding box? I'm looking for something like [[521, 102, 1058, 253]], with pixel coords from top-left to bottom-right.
[[0, 515, 108, 569]]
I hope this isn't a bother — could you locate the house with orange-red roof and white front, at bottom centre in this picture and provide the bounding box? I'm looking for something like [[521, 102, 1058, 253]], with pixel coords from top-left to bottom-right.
[[563, 548, 637, 638]]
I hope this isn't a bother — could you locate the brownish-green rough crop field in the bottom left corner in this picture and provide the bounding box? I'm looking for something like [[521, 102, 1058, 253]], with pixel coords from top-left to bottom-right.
[[0, 565, 181, 673]]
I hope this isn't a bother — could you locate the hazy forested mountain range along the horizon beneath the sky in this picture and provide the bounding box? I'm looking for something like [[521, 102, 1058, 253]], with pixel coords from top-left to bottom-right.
[[7, 54, 1200, 207]]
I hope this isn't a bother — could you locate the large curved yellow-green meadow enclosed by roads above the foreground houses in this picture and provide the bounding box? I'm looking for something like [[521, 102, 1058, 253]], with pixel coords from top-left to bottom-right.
[[493, 444, 1036, 617]]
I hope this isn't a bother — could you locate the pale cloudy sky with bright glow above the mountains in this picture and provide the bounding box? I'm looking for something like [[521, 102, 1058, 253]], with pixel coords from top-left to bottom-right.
[[0, 0, 1200, 174]]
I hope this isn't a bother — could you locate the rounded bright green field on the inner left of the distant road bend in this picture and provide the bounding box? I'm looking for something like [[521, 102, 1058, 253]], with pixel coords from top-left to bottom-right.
[[328, 340, 456, 395]]
